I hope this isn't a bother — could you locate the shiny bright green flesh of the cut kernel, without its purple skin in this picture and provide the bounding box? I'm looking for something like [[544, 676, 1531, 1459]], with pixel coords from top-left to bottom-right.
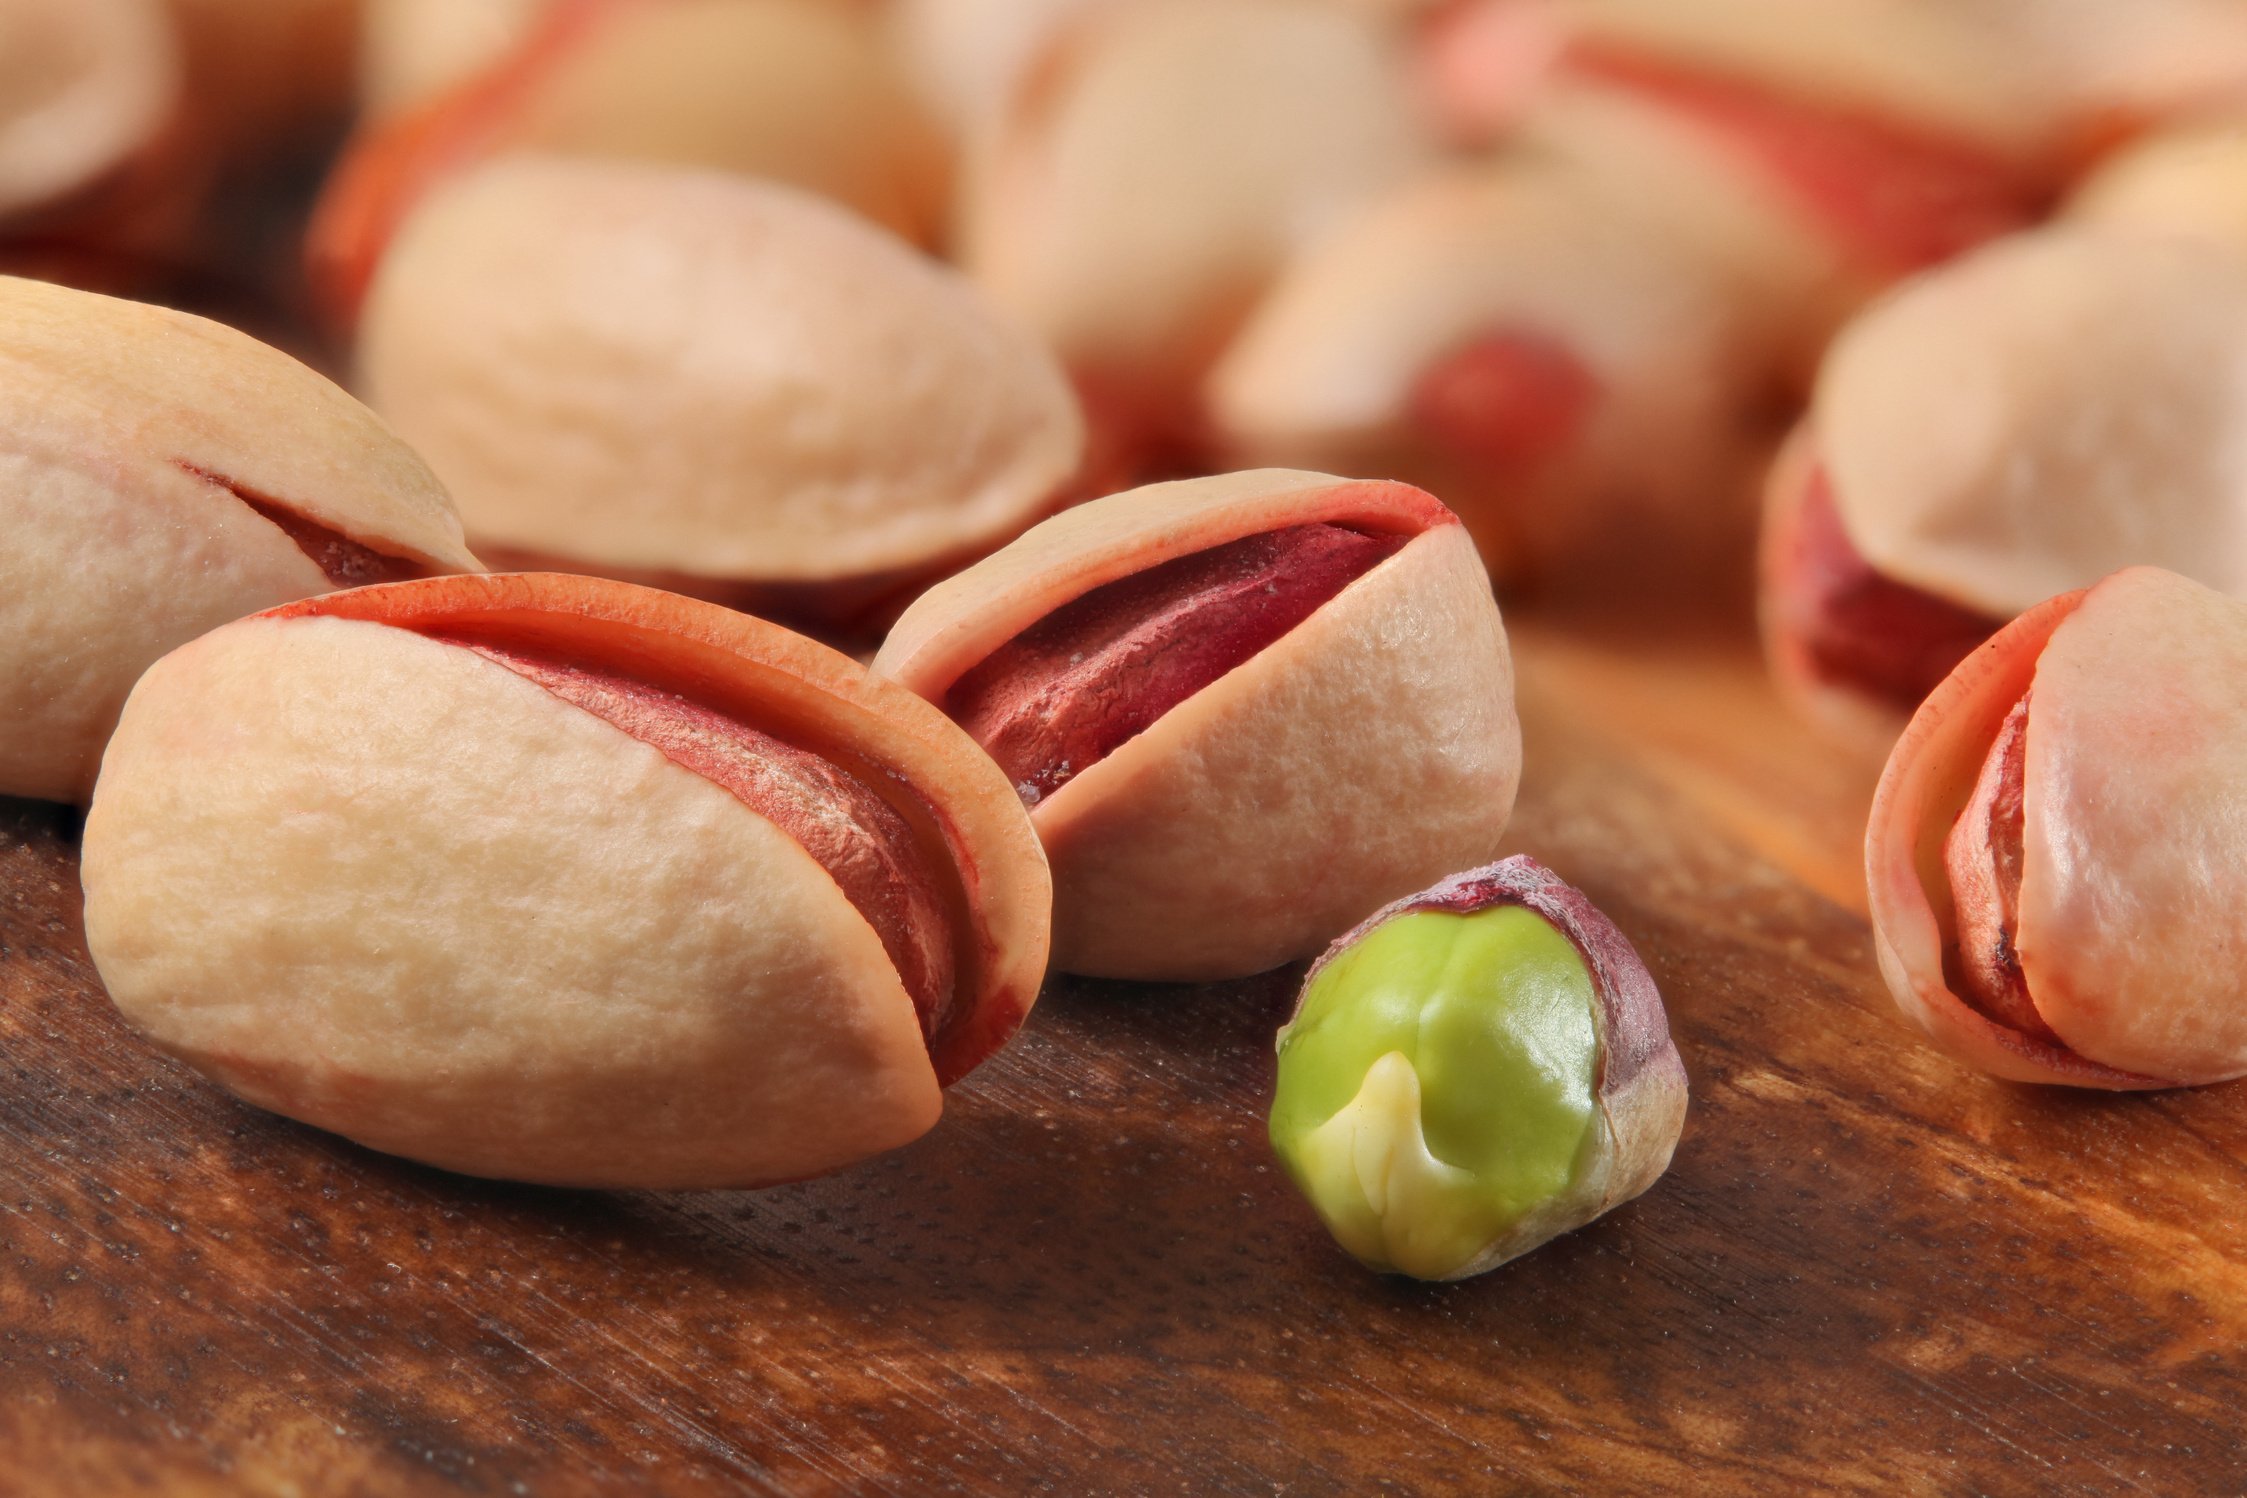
[[1272, 905, 1600, 1280]]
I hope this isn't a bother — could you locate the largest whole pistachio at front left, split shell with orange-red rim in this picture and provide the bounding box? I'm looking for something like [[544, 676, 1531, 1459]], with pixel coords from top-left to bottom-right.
[[83, 575, 1049, 1188]]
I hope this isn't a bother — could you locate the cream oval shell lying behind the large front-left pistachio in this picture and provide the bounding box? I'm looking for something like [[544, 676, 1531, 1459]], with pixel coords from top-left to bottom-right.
[[360, 157, 1083, 582]]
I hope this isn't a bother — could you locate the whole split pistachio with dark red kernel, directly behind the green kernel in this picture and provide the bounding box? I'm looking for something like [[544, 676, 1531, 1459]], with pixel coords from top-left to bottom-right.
[[874, 469, 1521, 979]]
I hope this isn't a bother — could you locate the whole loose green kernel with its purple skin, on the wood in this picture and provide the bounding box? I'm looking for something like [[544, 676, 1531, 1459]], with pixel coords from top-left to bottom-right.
[[1272, 858, 1685, 1280]]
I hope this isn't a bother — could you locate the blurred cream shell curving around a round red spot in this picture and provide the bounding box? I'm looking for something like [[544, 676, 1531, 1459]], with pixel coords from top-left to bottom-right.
[[1209, 117, 1825, 494]]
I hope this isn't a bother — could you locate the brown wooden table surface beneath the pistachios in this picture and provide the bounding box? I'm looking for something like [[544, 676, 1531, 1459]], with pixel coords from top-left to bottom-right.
[[0, 601, 2247, 1496]]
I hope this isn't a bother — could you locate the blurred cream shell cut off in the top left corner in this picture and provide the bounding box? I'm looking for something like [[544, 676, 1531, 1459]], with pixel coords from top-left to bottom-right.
[[0, 0, 182, 213]]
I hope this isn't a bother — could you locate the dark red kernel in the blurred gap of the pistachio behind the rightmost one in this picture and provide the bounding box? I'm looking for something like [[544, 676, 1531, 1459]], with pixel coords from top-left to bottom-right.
[[1771, 467, 2004, 712]]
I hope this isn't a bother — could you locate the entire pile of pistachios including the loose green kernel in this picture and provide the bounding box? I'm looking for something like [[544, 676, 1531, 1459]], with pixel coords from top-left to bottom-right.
[[13, 0, 2247, 1278]]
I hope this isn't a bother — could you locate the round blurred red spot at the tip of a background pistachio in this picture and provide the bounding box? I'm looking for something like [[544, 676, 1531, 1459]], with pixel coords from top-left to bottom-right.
[[1407, 330, 1600, 467]]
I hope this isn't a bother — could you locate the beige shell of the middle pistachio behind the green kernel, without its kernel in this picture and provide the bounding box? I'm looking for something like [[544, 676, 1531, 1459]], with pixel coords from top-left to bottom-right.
[[874, 469, 1521, 981]]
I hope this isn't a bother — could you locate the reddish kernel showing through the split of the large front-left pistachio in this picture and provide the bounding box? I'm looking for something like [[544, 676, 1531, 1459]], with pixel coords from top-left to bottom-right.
[[444, 633, 955, 1040]]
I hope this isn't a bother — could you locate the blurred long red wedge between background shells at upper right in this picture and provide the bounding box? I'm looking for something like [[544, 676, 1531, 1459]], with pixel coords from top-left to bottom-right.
[[1568, 47, 2045, 270]]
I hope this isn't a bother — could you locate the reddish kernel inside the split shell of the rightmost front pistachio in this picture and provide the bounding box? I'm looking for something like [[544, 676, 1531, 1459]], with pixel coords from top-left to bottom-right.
[[1944, 696, 2060, 1044]]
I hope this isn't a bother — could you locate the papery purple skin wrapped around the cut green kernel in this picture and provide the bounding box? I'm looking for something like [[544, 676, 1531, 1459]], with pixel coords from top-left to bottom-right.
[[1297, 856, 1687, 1239]]
